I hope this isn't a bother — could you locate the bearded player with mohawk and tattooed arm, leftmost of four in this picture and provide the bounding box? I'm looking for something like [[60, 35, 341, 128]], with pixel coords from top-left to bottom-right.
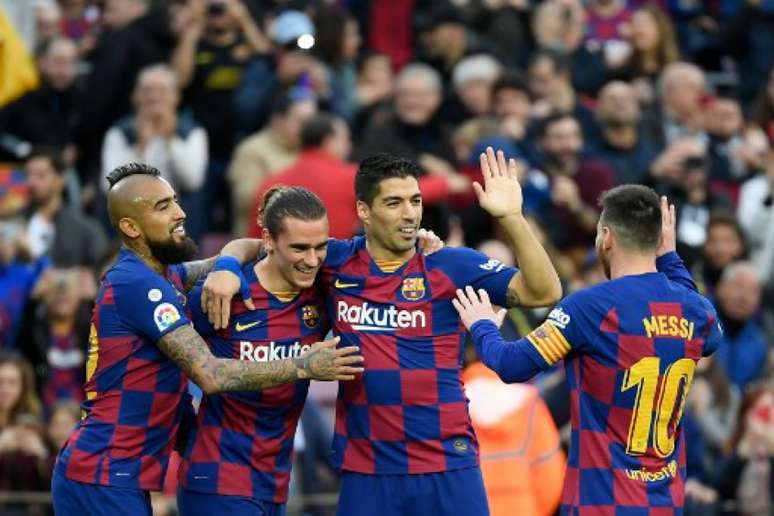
[[52, 164, 356, 516]]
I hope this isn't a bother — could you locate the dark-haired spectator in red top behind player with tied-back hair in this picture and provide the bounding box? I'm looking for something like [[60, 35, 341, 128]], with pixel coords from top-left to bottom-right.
[[247, 114, 360, 239]]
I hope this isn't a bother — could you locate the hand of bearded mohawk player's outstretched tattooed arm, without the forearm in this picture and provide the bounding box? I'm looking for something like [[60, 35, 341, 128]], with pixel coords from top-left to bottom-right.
[[295, 337, 363, 381]]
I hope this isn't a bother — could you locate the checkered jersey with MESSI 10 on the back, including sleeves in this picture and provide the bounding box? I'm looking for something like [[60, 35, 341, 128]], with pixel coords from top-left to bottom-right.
[[472, 253, 722, 516]]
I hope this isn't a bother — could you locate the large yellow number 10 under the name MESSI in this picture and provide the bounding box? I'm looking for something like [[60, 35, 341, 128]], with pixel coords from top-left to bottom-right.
[[621, 357, 696, 457]]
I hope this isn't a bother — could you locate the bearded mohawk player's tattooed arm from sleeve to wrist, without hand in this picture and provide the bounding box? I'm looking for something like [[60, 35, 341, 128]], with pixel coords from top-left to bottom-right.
[[158, 325, 300, 392]]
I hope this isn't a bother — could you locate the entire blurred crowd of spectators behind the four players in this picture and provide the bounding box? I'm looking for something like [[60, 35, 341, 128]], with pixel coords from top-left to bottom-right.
[[0, 0, 774, 515]]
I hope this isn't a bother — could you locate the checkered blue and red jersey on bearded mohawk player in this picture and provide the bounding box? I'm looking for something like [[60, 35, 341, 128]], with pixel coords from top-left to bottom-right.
[[56, 248, 192, 490]]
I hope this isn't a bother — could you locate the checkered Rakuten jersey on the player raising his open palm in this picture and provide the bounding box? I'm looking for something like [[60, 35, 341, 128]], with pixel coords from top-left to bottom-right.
[[320, 237, 516, 474]]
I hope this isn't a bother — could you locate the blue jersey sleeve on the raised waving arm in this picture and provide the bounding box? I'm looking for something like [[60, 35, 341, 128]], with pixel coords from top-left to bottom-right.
[[428, 247, 518, 306]]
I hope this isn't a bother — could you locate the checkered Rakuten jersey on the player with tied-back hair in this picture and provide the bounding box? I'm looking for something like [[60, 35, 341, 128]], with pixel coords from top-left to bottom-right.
[[179, 262, 329, 503]]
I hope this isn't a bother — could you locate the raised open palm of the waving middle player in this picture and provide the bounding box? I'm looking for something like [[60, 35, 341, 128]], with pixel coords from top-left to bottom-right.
[[473, 147, 522, 218]]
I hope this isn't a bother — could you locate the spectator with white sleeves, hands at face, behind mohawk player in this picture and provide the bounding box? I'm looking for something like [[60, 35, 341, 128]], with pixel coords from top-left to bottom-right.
[[100, 65, 209, 240]]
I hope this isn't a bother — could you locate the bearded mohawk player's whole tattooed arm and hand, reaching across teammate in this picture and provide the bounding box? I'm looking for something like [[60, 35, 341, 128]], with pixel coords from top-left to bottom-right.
[[157, 325, 363, 394]]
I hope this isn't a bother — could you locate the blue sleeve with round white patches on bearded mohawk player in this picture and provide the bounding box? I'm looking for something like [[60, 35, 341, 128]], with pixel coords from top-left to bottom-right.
[[113, 274, 191, 342]]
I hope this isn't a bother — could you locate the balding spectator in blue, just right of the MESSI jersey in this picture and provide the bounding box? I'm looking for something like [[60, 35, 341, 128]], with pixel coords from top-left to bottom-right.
[[715, 262, 768, 391]]
